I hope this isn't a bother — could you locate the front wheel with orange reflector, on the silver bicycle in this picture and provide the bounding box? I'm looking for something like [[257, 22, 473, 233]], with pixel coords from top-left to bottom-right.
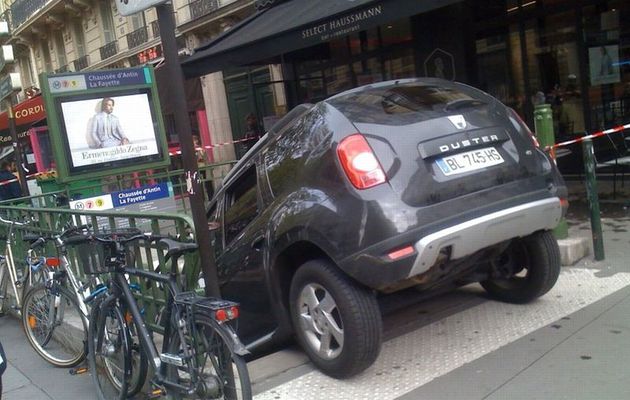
[[22, 283, 87, 367]]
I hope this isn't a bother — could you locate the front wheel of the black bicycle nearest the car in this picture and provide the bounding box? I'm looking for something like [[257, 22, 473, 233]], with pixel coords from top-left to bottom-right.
[[88, 306, 131, 400]]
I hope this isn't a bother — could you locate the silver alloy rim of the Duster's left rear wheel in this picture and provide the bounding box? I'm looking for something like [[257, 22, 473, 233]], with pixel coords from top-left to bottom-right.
[[298, 283, 344, 360]]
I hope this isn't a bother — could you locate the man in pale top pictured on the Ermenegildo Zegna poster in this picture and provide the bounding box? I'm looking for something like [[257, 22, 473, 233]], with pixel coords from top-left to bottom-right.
[[87, 97, 129, 149]]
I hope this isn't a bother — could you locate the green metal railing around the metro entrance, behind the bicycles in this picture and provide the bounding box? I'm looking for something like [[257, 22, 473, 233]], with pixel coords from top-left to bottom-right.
[[0, 161, 239, 331]]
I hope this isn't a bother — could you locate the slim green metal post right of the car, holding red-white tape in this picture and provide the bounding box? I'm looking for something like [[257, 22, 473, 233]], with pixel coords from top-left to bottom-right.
[[582, 139, 605, 261]]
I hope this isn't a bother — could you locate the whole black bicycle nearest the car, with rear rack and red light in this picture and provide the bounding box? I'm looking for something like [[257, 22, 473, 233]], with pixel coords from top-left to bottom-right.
[[85, 229, 252, 400]]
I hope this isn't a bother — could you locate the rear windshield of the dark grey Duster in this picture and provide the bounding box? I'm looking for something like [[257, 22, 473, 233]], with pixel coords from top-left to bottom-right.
[[327, 82, 492, 125]]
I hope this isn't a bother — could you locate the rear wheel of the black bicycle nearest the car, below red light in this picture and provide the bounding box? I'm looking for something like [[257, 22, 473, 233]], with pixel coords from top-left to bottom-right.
[[167, 314, 252, 400]]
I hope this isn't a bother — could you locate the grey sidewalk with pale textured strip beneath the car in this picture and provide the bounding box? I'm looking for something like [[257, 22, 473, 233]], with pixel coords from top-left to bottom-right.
[[0, 180, 630, 400]]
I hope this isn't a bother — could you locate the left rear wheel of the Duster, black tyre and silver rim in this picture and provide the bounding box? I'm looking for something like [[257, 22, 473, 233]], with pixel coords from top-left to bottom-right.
[[290, 260, 382, 378]]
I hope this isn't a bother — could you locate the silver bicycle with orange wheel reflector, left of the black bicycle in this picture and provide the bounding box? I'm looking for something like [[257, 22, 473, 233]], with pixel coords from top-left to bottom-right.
[[22, 225, 148, 394]]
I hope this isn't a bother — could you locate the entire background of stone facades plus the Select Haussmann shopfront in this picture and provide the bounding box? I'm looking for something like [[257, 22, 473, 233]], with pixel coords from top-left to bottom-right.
[[2, 0, 630, 175]]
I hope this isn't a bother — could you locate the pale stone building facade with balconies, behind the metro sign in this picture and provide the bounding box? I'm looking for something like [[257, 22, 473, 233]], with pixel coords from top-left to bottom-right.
[[0, 0, 255, 166]]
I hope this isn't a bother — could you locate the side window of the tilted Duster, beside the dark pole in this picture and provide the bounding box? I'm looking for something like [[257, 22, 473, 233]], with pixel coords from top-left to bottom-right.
[[224, 166, 259, 243]]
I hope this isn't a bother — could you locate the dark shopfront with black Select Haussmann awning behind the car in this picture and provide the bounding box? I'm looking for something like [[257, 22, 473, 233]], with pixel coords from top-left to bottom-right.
[[184, 0, 630, 170]]
